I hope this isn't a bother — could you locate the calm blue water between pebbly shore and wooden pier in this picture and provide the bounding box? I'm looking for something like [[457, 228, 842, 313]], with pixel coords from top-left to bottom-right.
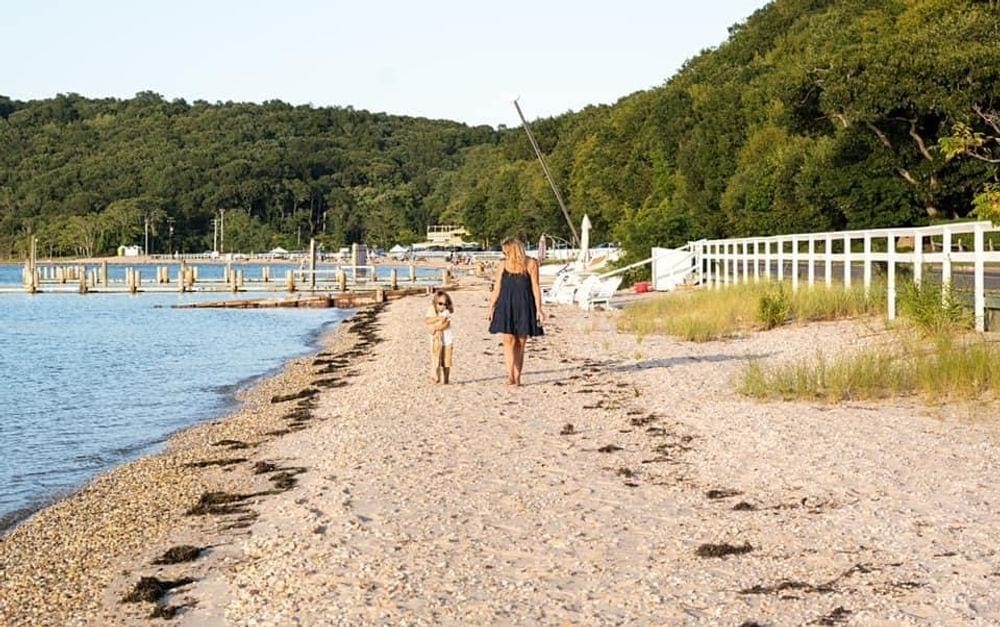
[[0, 286, 350, 531]]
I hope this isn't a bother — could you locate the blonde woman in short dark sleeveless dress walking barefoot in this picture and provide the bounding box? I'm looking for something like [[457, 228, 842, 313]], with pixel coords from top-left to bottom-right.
[[489, 239, 544, 386]]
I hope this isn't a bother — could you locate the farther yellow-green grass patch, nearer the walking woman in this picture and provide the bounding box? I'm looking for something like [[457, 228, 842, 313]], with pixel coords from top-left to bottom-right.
[[618, 282, 885, 342]]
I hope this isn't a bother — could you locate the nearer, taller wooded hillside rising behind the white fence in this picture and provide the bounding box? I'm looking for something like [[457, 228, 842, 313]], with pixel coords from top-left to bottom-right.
[[445, 0, 1000, 258]]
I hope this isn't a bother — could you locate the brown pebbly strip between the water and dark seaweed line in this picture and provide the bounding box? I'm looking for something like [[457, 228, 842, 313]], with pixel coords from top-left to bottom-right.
[[0, 305, 381, 625]]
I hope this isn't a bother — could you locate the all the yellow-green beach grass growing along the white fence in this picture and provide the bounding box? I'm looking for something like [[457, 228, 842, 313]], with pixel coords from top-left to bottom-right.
[[618, 281, 1000, 402]]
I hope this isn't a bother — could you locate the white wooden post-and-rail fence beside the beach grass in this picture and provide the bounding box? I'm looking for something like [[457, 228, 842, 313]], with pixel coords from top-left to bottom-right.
[[688, 222, 1000, 331]]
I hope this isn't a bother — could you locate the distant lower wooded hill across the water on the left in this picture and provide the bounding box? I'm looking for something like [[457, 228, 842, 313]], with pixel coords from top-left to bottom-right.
[[0, 93, 496, 257]]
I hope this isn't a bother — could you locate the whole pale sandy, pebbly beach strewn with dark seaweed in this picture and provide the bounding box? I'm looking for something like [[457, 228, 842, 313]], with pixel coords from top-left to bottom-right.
[[0, 280, 1000, 625]]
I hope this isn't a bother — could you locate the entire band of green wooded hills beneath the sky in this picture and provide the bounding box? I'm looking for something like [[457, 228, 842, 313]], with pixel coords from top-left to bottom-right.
[[0, 0, 1000, 256]]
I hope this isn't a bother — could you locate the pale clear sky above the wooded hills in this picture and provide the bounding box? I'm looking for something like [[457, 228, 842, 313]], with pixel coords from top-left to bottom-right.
[[0, 0, 767, 126]]
